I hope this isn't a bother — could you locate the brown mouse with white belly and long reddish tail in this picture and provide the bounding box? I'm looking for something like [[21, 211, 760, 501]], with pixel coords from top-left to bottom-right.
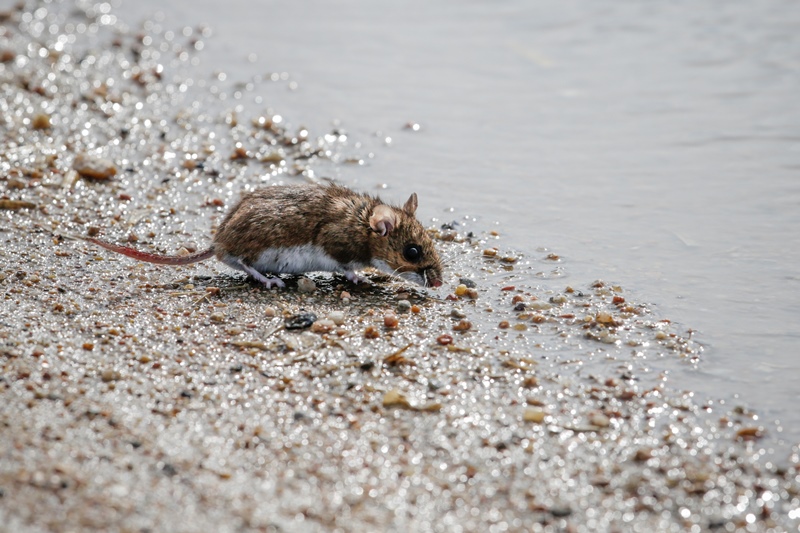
[[82, 184, 442, 288]]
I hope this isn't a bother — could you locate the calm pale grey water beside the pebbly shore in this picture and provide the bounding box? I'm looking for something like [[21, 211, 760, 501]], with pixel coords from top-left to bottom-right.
[[114, 0, 800, 447]]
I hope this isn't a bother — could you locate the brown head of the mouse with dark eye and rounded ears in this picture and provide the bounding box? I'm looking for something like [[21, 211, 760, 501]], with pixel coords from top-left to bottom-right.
[[369, 193, 442, 287]]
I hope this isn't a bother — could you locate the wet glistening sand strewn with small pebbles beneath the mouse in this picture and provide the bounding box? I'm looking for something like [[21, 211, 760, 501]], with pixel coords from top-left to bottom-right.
[[0, 4, 800, 531]]
